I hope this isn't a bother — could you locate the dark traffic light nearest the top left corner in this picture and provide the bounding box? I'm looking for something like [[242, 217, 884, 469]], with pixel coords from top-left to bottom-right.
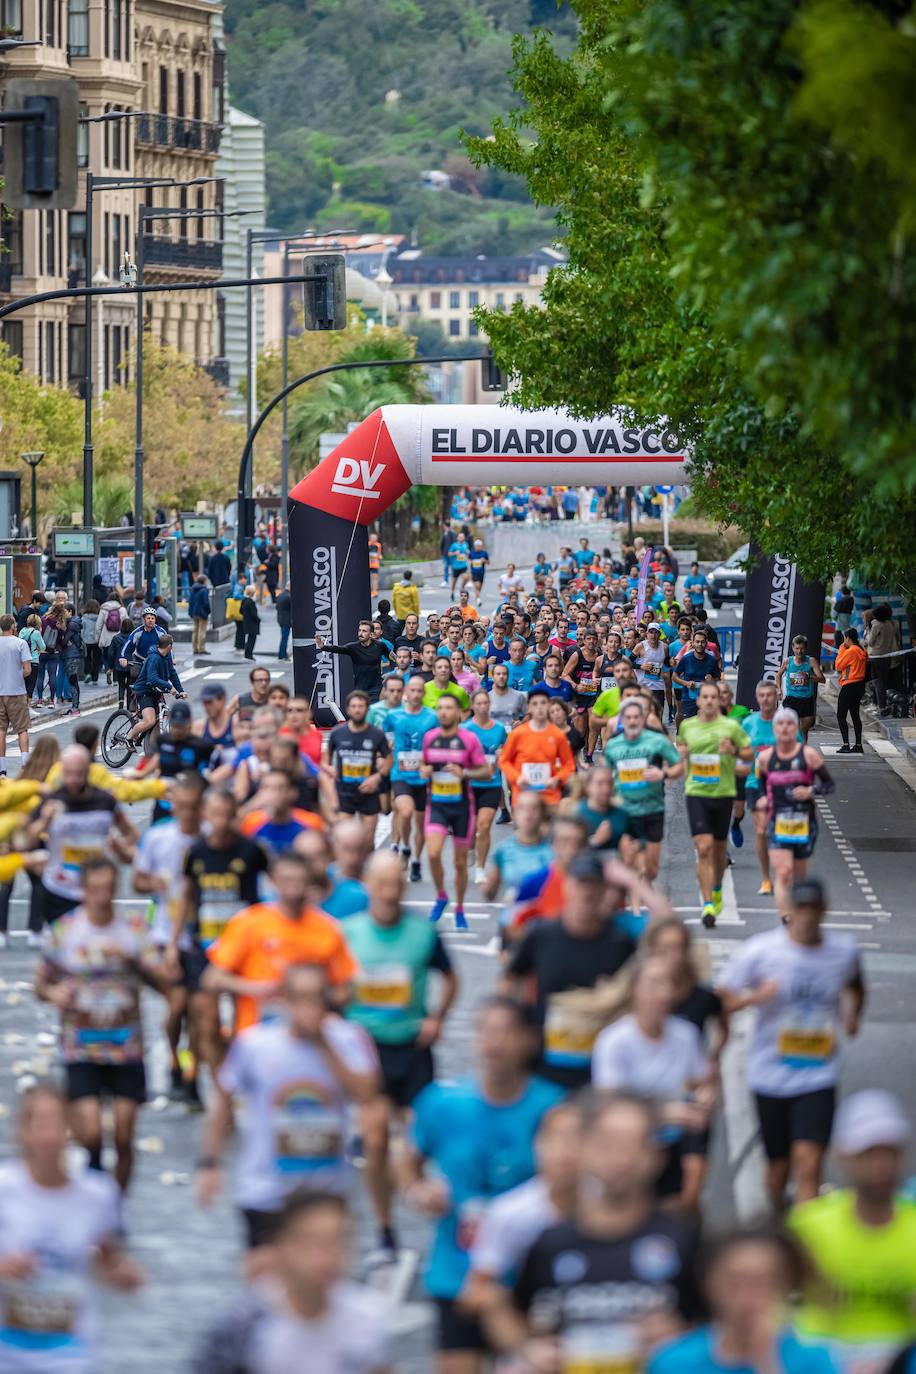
[[0, 77, 80, 210]]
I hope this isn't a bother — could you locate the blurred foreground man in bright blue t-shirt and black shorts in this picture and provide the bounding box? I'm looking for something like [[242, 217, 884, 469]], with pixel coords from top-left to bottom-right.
[[402, 998, 562, 1374]]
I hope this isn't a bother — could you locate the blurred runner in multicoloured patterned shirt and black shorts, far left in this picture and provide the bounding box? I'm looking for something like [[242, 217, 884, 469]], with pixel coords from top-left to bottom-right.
[[34, 856, 169, 1193]]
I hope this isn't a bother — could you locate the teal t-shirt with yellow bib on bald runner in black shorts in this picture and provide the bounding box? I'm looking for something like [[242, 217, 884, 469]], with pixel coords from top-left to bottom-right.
[[346, 911, 452, 1044]]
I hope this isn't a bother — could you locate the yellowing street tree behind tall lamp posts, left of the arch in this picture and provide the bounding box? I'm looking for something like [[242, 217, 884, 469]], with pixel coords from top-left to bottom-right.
[[96, 335, 244, 510]]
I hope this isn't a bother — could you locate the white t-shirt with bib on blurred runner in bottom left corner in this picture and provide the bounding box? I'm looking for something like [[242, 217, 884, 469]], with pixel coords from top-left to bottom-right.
[[0, 1160, 121, 1374]]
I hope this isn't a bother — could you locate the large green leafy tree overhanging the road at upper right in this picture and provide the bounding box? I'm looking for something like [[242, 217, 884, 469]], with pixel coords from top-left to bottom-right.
[[468, 0, 916, 585]]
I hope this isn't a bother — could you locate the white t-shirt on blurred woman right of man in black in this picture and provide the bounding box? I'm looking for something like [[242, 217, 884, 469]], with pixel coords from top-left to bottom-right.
[[592, 1015, 709, 1102]]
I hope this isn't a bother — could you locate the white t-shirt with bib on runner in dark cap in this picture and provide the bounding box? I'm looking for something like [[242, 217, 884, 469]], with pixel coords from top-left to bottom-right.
[[721, 926, 861, 1098]]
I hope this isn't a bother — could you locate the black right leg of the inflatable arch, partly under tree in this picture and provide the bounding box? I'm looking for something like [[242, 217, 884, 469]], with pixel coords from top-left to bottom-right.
[[735, 544, 824, 710]]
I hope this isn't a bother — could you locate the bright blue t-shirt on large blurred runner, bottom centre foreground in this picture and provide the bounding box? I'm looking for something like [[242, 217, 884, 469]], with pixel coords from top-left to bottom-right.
[[409, 1071, 566, 1298]]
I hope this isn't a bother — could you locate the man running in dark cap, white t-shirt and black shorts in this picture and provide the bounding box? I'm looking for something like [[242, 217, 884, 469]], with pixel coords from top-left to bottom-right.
[[720, 879, 865, 1216]]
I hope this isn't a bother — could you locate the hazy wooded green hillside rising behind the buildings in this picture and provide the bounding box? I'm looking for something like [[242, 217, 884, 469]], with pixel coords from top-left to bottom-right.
[[225, 0, 575, 253]]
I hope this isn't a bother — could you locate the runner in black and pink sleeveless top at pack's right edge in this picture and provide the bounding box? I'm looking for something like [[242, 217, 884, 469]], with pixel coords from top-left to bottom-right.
[[757, 706, 835, 921]]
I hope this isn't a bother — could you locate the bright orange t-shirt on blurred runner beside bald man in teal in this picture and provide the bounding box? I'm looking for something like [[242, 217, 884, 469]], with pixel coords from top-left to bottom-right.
[[207, 901, 357, 1031]]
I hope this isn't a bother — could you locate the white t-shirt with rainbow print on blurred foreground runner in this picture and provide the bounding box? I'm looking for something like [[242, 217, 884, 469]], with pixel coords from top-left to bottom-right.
[[220, 1015, 379, 1212]]
